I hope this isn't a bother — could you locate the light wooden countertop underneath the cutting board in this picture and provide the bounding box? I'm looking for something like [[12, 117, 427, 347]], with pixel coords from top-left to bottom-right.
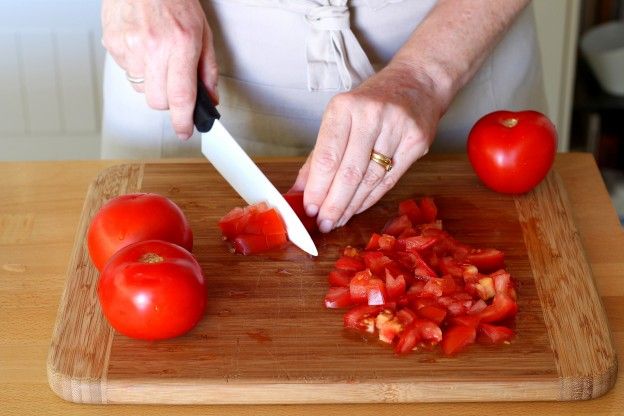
[[0, 153, 624, 416]]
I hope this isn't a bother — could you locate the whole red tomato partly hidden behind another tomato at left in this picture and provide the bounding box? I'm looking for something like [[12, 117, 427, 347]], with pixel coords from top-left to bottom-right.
[[87, 193, 193, 271]]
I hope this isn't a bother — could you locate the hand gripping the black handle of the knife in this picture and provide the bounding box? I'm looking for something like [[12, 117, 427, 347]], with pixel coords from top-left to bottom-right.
[[102, 0, 218, 139]]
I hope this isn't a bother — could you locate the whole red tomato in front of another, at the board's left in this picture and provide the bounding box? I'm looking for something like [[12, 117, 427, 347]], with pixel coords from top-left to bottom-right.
[[98, 240, 206, 340]]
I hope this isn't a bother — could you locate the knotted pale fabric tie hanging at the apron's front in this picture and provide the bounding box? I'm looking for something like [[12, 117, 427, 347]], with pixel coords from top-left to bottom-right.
[[305, 0, 375, 91]]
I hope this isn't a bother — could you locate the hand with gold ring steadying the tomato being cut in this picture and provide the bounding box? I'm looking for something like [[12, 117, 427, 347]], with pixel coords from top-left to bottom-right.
[[293, 64, 446, 232]]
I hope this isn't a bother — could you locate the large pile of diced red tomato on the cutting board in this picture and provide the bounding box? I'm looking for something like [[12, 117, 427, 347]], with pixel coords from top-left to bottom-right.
[[325, 197, 518, 355]]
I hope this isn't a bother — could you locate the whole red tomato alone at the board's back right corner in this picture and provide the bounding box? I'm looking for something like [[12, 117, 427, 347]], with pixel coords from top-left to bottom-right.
[[468, 111, 557, 194]]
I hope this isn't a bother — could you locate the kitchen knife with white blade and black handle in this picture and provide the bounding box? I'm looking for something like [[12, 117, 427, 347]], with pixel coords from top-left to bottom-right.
[[193, 82, 318, 256]]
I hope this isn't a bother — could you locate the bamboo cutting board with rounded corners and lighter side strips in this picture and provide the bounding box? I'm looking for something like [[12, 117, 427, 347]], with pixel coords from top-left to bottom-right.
[[47, 159, 617, 404]]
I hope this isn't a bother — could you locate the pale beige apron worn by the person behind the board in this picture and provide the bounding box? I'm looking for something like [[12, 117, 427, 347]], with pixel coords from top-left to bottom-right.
[[102, 0, 546, 158]]
